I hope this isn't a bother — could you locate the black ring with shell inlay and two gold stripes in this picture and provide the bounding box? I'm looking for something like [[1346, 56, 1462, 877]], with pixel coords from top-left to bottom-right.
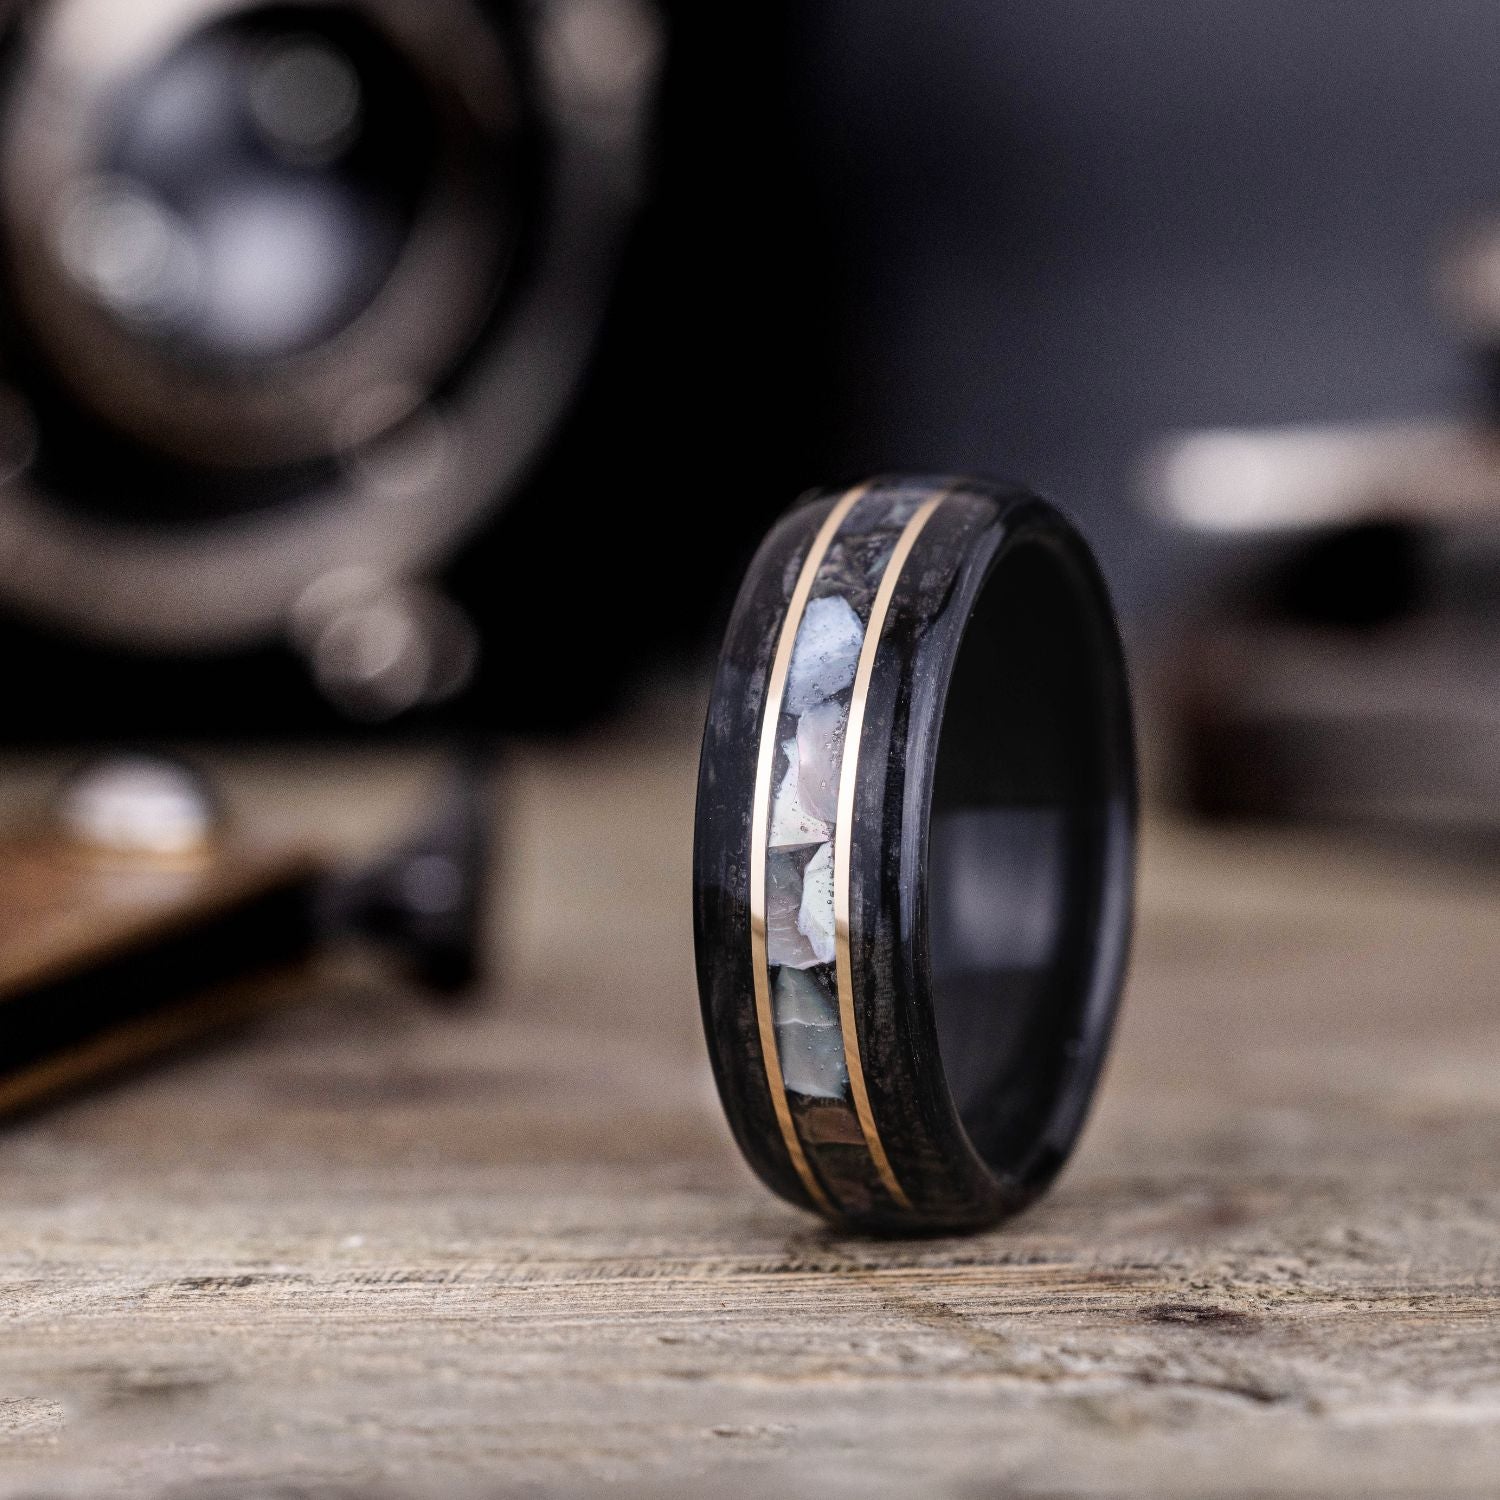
[[693, 479, 1136, 1233]]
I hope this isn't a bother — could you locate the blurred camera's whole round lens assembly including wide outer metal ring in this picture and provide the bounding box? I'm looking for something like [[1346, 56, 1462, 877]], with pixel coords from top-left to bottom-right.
[[0, 0, 662, 660]]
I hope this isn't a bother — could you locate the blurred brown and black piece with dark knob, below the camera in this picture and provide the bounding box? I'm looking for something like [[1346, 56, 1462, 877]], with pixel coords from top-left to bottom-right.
[[0, 753, 489, 1116]]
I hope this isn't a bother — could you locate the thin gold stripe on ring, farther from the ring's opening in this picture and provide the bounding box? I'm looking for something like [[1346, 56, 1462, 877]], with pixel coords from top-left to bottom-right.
[[750, 485, 870, 1214]]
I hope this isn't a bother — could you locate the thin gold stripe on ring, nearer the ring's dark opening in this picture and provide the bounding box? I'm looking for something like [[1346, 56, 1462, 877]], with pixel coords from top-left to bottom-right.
[[834, 491, 950, 1209]]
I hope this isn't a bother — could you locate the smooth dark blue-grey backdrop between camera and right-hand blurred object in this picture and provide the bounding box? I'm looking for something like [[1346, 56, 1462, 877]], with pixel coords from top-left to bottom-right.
[[797, 0, 1500, 617]]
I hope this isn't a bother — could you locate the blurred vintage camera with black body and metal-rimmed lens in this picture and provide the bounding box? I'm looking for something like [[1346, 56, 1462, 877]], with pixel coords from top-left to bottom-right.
[[0, 0, 818, 738]]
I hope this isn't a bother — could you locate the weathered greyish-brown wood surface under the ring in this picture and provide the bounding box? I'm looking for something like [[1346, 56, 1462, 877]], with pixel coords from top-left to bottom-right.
[[0, 716, 1500, 1500]]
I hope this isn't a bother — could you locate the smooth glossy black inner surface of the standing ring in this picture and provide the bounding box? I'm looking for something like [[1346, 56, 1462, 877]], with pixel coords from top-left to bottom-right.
[[929, 540, 1110, 1176]]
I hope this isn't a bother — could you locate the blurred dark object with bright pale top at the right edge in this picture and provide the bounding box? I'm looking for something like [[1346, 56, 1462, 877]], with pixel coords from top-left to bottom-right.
[[1149, 225, 1500, 846]]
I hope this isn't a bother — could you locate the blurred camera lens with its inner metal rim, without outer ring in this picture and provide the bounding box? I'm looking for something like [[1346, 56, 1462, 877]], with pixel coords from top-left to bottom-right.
[[0, 0, 525, 477]]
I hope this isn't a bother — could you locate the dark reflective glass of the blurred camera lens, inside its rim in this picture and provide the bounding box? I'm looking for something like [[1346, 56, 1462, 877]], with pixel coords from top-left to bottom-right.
[[56, 11, 438, 366]]
